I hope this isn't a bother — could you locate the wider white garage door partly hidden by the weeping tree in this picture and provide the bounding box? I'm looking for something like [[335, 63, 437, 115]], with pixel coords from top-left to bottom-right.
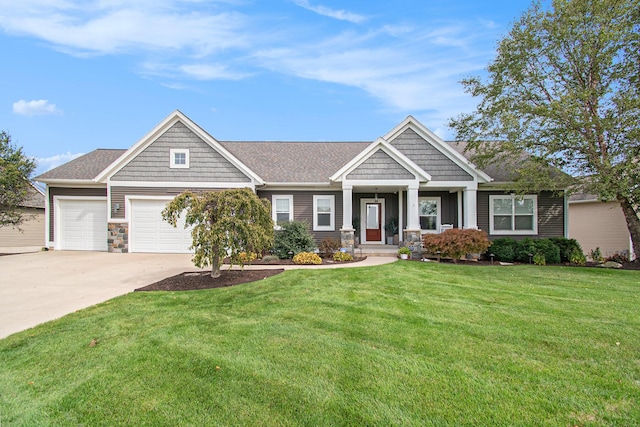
[[129, 199, 193, 254]]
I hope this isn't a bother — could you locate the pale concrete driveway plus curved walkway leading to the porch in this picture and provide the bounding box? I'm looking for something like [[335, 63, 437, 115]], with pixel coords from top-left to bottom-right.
[[0, 251, 396, 339]]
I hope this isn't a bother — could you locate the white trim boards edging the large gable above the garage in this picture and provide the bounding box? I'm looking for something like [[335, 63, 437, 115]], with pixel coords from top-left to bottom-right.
[[96, 110, 264, 184]]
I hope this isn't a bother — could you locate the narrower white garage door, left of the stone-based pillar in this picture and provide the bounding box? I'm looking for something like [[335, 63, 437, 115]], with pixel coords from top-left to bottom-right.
[[57, 199, 107, 251]]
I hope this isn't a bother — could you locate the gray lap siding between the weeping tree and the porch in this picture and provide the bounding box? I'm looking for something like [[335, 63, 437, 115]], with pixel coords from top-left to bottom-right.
[[258, 190, 343, 244]]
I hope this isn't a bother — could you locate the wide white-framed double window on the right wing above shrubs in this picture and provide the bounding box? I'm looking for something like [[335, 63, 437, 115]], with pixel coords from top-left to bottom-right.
[[489, 194, 538, 235]]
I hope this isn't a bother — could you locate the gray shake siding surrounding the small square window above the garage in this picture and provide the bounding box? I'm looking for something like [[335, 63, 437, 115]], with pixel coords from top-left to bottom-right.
[[111, 122, 251, 183]]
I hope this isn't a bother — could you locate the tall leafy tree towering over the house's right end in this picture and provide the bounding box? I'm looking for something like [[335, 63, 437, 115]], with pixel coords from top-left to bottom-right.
[[450, 0, 640, 258]]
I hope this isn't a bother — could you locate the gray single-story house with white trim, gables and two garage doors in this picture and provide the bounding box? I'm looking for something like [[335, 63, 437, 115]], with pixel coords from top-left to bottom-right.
[[37, 111, 566, 253]]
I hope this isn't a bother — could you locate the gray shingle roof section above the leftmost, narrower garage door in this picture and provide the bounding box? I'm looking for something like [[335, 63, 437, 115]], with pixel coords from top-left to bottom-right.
[[33, 148, 127, 181]]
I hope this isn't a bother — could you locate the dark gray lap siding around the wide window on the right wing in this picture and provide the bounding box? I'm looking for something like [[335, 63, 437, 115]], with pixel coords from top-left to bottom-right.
[[477, 191, 566, 240]]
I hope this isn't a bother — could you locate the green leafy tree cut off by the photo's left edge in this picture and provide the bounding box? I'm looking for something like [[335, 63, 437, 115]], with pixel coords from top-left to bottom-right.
[[0, 131, 36, 227]]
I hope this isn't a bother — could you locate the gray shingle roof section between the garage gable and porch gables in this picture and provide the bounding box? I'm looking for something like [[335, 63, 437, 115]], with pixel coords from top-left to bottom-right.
[[220, 141, 371, 183]]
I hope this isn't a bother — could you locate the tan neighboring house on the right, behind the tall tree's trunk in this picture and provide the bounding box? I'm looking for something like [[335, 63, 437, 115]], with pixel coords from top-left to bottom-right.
[[569, 193, 634, 257]]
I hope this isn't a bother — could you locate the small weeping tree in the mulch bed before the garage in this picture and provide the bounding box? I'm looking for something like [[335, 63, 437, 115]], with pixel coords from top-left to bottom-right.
[[162, 188, 273, 279]]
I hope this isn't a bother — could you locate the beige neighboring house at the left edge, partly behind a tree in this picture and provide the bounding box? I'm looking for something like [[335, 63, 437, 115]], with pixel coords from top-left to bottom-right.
[[0, 185, 45, 254]]
